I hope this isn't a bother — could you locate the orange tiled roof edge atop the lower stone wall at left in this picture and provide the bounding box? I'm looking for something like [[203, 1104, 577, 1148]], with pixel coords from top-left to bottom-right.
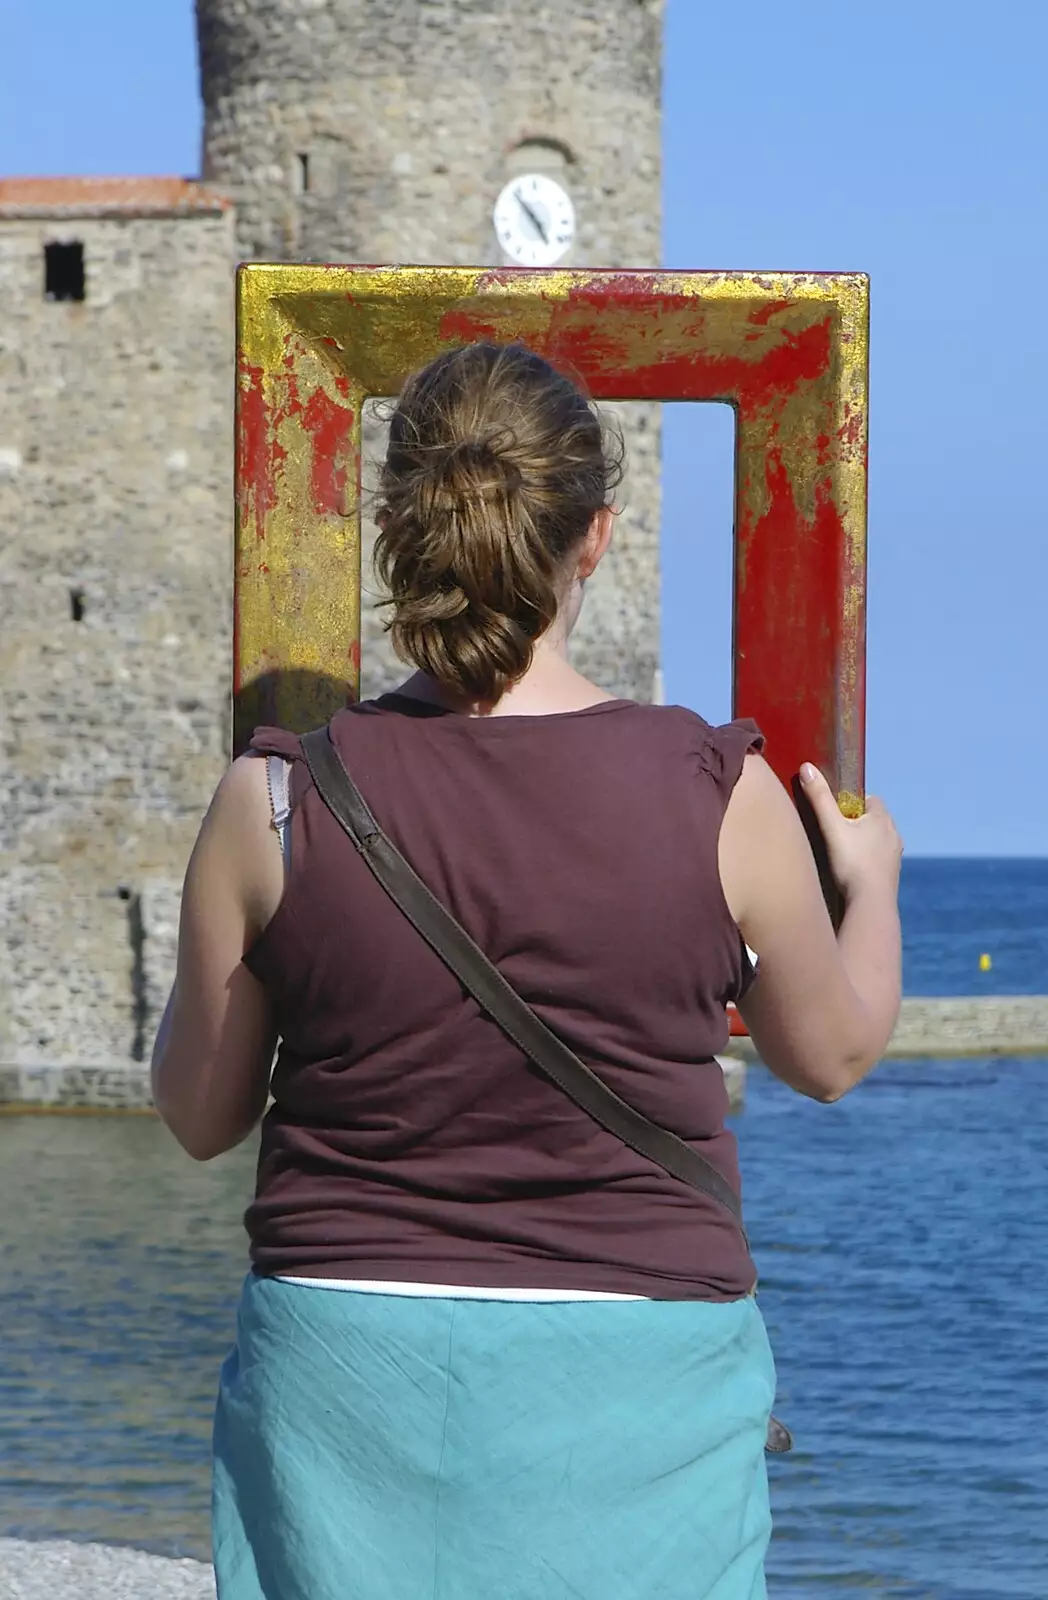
[[0, 178, 232, 218]]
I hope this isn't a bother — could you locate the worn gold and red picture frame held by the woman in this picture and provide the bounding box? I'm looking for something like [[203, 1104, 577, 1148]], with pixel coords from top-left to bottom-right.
[[234, 266, 869, 813]]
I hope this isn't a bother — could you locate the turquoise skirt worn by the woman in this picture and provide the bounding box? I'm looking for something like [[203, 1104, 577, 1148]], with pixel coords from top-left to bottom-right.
[[213, 1277, 774, 1600]]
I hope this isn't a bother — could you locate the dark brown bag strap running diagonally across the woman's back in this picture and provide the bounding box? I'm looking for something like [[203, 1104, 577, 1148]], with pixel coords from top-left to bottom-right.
[[302, 728, 746, 1238]]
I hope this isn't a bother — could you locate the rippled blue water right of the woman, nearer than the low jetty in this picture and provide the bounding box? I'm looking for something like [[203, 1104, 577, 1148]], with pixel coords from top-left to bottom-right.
[[738, 1059, 1048, 1600]]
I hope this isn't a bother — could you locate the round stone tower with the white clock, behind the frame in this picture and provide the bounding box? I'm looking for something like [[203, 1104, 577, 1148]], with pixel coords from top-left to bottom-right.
[[197, 0, 662, 699]]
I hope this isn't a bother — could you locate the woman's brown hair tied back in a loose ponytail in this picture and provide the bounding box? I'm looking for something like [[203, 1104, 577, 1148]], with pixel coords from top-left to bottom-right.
[[374, 344, 622, 704]]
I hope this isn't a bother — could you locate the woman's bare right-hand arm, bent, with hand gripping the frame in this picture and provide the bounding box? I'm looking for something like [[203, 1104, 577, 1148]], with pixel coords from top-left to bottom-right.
[[720, 755, 902, 1101]]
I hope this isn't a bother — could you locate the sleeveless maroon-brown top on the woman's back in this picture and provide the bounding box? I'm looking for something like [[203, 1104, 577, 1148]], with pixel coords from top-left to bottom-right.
[[245, 696, 760, 1299]]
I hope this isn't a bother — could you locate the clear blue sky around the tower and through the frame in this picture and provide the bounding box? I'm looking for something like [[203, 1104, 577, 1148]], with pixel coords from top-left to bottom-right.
[[0, 0, 1048, 856]]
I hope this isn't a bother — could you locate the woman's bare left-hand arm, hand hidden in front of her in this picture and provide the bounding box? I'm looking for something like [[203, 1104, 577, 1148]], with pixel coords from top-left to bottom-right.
[[152, 757, 283, 1162]]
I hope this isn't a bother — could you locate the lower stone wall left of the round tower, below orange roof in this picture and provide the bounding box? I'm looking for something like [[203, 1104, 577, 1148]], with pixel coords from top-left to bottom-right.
[[0, 206, 234, 1067]]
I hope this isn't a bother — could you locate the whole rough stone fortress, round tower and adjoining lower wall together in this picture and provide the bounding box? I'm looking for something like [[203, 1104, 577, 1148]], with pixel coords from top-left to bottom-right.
[[0, 0, 662, 1102]]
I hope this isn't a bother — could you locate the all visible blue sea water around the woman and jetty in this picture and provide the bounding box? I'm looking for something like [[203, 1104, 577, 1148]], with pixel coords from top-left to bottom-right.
[[0, 859, 1048, 1600]]
